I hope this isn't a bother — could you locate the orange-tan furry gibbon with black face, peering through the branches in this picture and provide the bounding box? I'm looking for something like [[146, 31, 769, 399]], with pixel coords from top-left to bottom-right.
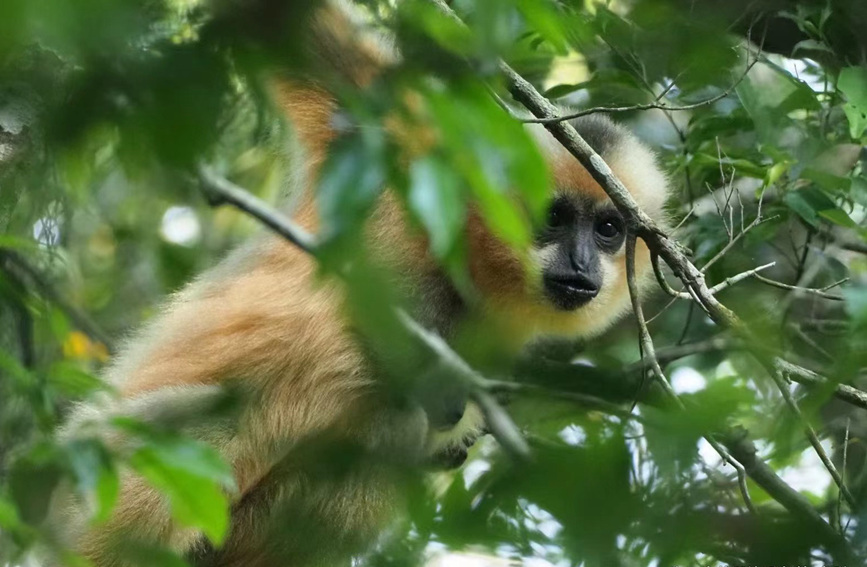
[[47, 5, 668, 567]]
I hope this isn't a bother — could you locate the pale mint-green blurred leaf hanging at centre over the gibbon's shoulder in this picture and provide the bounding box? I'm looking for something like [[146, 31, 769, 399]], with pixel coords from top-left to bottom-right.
[[408, 156, 465, 258]]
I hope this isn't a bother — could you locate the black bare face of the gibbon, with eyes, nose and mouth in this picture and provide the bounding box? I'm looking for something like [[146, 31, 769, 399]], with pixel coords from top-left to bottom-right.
[[536, 194, 626, 311]]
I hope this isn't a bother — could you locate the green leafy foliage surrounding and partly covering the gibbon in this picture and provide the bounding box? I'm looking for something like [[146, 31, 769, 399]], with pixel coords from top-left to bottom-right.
[[0, 0, 867, 566]]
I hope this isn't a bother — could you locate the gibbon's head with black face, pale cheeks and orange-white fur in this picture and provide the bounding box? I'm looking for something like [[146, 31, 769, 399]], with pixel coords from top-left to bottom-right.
[[468, 116, 668, 344]]
